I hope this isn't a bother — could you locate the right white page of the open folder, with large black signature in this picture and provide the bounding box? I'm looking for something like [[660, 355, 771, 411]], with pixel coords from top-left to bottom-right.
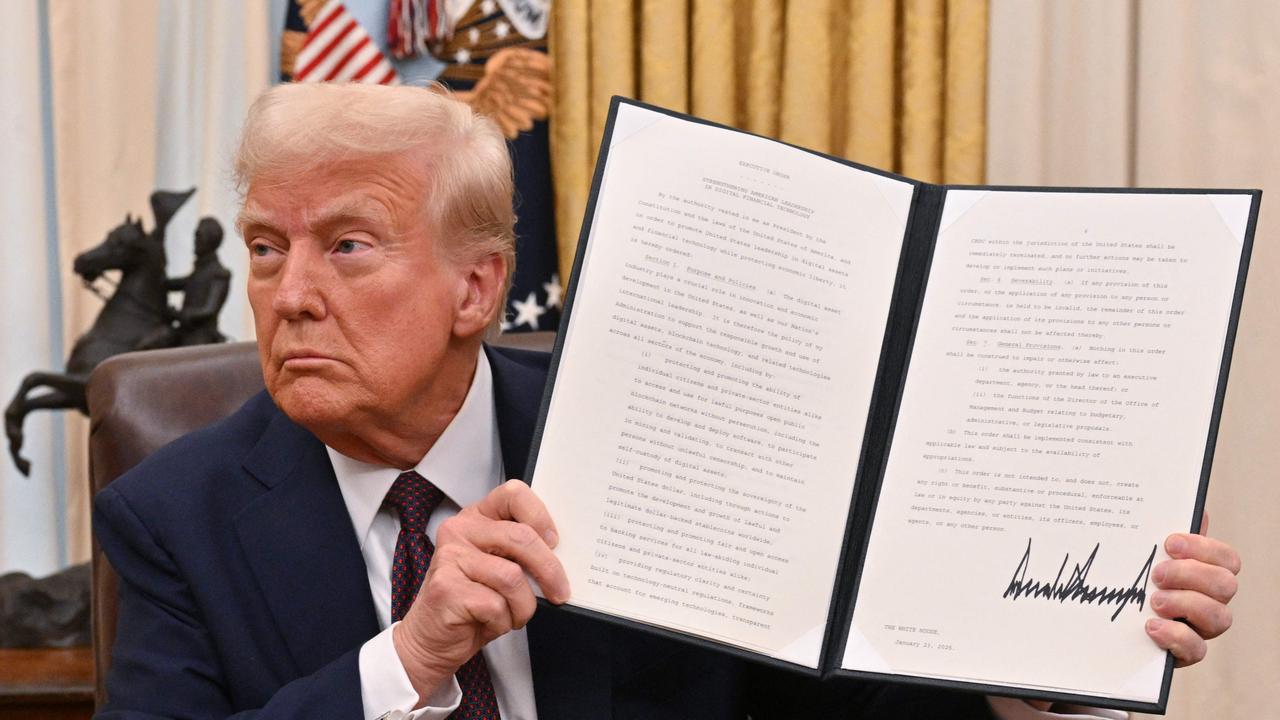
[[844, 191, 1251, 702]]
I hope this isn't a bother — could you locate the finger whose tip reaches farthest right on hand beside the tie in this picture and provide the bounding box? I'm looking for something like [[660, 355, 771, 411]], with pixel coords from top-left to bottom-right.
[[436, 515, 568, 603]]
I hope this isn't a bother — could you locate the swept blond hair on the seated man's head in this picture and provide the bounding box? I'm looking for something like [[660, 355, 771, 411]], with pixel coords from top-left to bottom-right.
[[234, 83, 516, 297]]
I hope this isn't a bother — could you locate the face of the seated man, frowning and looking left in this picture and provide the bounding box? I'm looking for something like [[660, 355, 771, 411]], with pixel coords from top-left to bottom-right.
[[242, 159, 468, 434]]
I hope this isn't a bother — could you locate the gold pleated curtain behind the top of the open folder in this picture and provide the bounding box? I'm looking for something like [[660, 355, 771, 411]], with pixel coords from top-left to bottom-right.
[[550, 0, 987, 278]]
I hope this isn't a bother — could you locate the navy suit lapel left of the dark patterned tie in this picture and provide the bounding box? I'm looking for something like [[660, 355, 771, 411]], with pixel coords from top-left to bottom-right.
[[234, 413, 378, 675]]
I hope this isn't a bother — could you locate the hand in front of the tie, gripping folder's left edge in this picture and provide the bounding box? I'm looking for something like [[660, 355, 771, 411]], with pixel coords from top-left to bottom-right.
[[392, 480, 568, 702]]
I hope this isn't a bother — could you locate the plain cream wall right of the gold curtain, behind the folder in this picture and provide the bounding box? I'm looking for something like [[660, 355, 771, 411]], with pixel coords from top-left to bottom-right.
[[987, 0, 1280, 720]]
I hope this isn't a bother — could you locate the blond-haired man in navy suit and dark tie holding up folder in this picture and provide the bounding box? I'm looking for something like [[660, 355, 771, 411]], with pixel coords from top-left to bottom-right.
[[95, 85, 1239, 720]]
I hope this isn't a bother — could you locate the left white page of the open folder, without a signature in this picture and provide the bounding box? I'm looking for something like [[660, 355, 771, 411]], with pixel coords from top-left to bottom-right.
[[532, 105, 913, 667]]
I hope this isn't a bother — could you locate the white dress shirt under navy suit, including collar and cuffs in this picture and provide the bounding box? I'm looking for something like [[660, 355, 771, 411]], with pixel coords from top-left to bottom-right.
[[326, 352, 1128, 720]]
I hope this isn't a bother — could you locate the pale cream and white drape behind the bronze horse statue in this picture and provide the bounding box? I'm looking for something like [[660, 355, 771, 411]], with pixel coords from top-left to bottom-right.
[[41, 0, 270, 562]]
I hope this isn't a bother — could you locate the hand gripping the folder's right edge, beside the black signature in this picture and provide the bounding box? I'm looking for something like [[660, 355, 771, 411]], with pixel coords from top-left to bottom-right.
[[1147, 514, 1240, 667]]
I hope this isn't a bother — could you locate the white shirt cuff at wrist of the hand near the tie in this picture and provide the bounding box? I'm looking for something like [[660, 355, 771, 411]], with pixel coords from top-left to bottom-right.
[[360, 624, 462, 720]]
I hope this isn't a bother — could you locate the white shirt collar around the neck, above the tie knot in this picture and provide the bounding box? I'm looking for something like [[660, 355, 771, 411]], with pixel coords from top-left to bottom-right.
[[325, 352, 503, 547]]
